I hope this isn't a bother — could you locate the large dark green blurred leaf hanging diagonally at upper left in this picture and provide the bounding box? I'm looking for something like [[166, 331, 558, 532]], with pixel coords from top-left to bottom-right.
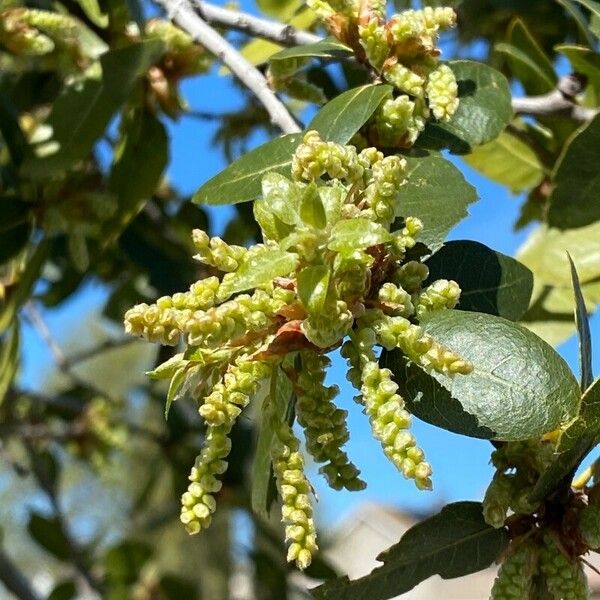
[[21, 40, 164, 178]]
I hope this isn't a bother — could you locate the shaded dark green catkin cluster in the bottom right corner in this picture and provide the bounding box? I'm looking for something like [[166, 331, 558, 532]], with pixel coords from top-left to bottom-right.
[[483, 435, 600, 600]]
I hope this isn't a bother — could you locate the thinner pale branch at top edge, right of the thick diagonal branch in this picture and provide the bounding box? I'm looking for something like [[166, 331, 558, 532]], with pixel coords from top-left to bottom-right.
[[192, 0, 321, 46]]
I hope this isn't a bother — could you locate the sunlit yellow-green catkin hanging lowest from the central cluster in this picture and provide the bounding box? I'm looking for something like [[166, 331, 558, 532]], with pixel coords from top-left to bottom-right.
[[271, 424, 318, 569]]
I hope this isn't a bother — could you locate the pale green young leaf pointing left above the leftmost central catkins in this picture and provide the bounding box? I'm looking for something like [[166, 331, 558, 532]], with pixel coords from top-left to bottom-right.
[[219, 247, 298, 298]]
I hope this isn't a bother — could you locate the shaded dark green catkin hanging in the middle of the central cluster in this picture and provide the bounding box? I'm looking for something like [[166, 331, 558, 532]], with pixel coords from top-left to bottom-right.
[[296, 352, 365, 491]]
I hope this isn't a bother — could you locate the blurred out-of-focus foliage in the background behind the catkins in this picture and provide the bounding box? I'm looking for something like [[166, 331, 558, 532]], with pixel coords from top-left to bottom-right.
[[0, 0, 600, 600]]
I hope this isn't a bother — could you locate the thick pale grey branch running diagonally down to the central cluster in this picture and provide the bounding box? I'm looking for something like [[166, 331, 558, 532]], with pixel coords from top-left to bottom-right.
[[155, 0, 301, 133]]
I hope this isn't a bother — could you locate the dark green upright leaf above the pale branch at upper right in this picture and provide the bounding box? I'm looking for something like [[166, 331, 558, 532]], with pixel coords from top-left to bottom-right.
[[495, 18, 557, 95]]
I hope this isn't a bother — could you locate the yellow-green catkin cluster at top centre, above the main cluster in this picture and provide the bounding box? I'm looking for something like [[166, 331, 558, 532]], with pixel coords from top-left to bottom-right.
[[300, 0, 459, 148]]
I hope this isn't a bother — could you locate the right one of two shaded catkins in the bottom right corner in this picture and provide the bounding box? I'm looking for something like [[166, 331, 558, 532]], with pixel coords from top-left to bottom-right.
[[540, 533, 589, 600]]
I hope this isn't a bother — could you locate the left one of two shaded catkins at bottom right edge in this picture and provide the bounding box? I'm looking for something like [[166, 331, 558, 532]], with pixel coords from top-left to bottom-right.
[[490, 542, 537, 600]]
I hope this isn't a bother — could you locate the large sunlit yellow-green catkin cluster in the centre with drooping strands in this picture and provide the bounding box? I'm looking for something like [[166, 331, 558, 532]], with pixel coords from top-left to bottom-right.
[[125, 131, 472, 569]]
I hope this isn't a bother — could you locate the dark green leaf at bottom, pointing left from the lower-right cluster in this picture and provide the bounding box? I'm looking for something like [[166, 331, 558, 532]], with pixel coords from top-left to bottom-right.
[[313, 502, 509, 600]]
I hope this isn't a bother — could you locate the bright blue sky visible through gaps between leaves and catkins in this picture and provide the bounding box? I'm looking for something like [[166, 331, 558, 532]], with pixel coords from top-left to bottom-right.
[[17, 0, 600, 524]]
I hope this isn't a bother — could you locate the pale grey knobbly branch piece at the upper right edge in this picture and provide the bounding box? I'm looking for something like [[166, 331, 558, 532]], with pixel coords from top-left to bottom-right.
[[512, 75, 599, 123]]
